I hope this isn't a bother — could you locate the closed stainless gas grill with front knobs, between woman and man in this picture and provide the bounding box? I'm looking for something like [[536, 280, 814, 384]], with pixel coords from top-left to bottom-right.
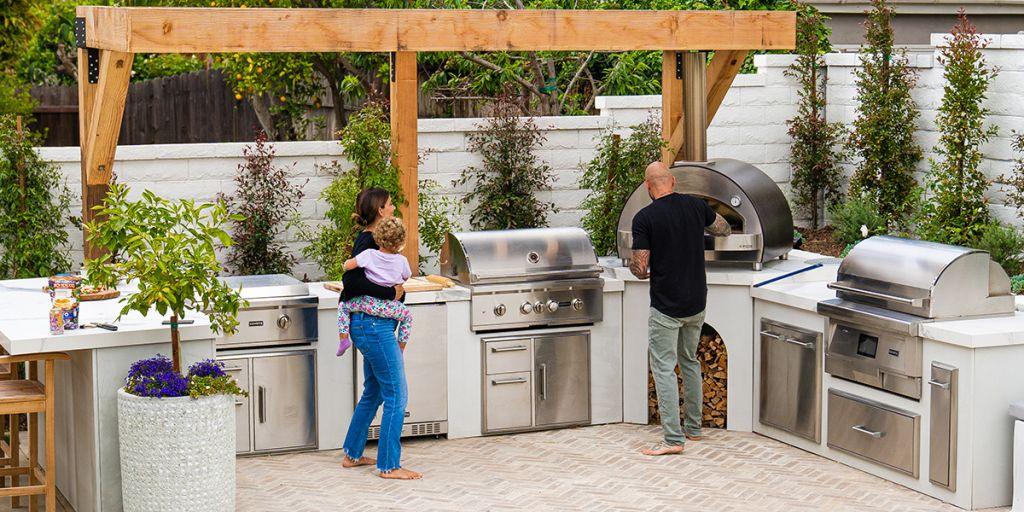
[[441, 227, 604, 332]]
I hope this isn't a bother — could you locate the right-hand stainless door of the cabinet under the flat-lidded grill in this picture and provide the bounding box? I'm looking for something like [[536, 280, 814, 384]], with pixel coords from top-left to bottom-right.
[[251, 350, 316, 452]]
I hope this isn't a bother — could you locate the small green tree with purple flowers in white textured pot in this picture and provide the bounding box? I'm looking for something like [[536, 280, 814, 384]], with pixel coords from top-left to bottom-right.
[[86, 184, 243, 511]]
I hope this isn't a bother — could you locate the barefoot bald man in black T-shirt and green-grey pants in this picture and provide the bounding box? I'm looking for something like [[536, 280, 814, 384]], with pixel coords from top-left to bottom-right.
[[630, 162, 731, 456]]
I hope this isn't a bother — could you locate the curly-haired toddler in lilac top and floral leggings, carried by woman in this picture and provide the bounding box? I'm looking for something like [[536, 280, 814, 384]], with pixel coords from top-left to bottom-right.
[[338, 217, 413, 356]]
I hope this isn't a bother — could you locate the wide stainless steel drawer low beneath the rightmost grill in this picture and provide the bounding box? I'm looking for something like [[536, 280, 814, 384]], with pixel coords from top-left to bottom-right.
[[828, 389, 921, 478]]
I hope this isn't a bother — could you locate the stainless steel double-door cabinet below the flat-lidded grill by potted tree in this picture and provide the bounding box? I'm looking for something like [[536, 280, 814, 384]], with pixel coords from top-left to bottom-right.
[[218, 350, 316, 454]]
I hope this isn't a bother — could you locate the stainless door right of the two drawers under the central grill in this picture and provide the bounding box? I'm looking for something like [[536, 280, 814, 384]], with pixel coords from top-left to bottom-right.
[[534, 333, 590, 427]]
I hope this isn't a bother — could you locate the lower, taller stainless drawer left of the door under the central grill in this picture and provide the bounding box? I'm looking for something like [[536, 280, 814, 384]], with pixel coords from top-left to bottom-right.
[[483, 371, 534, 432]]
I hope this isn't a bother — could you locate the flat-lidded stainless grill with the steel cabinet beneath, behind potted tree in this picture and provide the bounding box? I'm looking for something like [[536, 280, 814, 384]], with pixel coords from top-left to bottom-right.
[[216, 274, 318, 454]]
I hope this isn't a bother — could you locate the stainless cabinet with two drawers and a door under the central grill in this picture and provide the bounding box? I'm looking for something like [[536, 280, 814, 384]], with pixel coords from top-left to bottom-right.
[[482, 332, 590, 434]]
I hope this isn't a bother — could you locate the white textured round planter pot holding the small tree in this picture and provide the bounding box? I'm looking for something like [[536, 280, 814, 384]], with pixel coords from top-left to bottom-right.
[[118, 389, 234, 512]]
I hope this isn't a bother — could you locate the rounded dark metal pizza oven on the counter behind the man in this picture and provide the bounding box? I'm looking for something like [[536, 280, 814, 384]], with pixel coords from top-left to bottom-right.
[[616, 159, 793, 270]]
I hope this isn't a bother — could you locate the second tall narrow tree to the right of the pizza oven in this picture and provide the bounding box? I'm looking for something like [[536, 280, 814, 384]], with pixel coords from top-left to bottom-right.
[[849, 0, 922, 226]]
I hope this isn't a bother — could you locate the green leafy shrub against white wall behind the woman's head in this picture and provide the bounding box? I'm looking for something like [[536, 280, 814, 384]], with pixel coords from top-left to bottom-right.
[[299, 103, 406, 280]]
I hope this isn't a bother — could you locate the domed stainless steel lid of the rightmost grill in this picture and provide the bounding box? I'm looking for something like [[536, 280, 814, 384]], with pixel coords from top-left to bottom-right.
[[828, 237, 1015, 318]]
